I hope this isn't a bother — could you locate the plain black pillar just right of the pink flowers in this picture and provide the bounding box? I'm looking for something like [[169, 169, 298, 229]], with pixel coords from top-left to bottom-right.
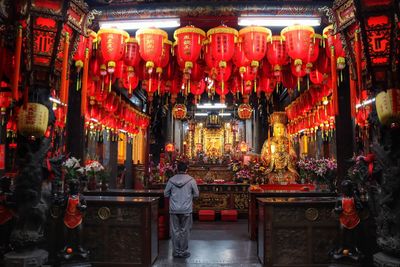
[[336, 68, 354, 180]]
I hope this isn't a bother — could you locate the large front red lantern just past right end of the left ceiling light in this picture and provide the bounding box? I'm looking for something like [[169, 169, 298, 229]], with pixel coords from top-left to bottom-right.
[[174, 26, 206, 75]]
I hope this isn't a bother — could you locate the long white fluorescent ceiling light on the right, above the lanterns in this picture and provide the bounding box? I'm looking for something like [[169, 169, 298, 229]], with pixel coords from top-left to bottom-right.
[[238, 16, 321, 27]]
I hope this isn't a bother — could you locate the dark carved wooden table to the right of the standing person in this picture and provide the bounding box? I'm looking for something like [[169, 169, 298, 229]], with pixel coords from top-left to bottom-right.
[[257, 197, 339, 267]]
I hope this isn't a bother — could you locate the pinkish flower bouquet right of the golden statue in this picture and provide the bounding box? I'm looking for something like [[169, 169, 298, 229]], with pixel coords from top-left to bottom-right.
[[297, 158, 337, 190]]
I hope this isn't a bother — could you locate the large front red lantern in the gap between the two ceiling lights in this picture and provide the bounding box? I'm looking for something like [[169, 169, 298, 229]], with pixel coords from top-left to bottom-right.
[[207, 25, 238, 68]]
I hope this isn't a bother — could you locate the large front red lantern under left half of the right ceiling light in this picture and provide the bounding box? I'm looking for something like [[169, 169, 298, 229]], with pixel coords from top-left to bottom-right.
[[239, 26, 272, 69]]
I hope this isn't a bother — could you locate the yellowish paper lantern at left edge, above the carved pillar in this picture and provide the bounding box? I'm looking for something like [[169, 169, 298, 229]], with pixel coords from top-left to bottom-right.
[[17, 103, 49, 137]]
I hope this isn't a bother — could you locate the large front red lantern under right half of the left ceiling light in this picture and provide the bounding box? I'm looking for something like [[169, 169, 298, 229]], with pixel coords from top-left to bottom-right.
[[136, 28, 168, 74]]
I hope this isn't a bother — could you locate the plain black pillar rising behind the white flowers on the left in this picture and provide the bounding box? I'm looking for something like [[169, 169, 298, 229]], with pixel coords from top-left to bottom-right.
[[66, 71, 85, 163]]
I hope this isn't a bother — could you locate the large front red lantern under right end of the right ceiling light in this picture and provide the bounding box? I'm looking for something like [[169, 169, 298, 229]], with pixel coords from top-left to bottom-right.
[[281, 25, 314, 72]]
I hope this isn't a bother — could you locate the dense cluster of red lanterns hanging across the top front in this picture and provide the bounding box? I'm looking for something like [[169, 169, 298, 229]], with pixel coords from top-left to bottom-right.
[[75, 22, 345, 109]]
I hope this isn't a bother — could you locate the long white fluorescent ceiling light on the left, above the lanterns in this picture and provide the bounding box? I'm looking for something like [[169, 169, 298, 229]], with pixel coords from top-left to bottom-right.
[[99, 18, 181, 30]]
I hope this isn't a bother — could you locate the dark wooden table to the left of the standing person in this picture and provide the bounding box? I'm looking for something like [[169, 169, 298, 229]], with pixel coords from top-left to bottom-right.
[[83, 196, 159, 266]]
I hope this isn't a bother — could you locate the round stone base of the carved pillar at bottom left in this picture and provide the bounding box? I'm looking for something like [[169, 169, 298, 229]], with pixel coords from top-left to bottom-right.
[[4, 249, 49, 267]]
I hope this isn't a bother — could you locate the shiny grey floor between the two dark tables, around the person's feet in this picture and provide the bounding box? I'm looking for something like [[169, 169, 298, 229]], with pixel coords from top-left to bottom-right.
[[153, 220, 261, 267]]
